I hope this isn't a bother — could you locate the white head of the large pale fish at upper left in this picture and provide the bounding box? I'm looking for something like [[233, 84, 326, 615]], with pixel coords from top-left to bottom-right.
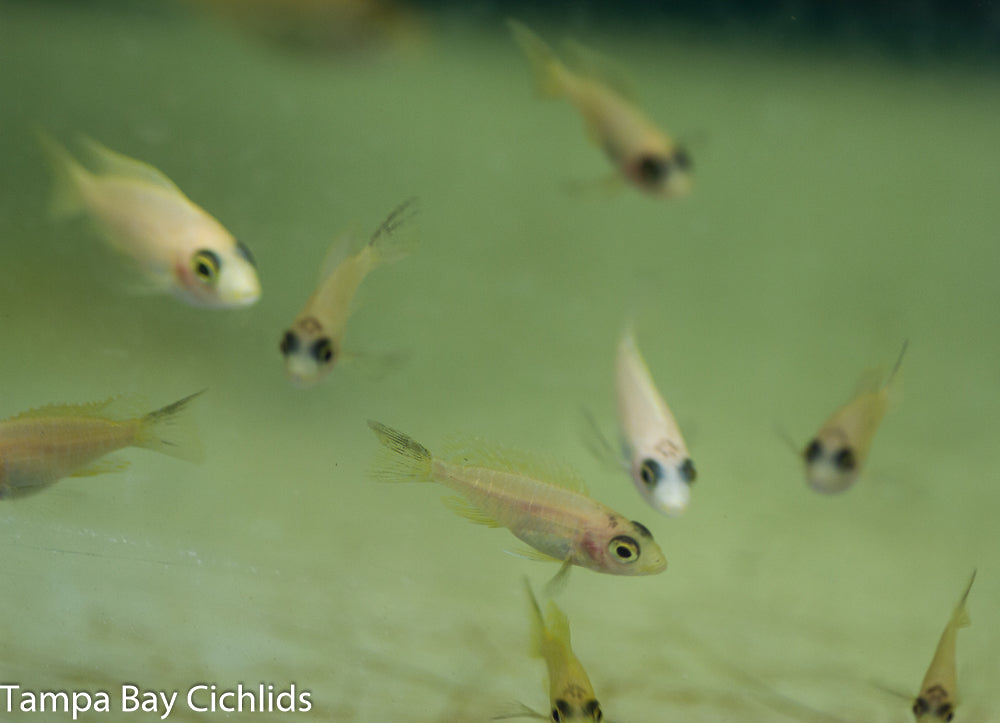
[[175, 241, 260, 308]]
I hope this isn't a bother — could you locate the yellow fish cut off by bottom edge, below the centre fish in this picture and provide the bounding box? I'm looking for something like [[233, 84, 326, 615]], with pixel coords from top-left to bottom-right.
[[525, 583, 604, 723]]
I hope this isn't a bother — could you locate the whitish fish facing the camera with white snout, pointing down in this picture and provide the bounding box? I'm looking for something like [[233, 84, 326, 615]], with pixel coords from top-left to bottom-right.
[[617, 329, 697, 517]]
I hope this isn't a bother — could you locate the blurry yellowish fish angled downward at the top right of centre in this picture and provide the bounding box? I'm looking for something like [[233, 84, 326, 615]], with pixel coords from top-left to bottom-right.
[[507, 20, 691, 198]]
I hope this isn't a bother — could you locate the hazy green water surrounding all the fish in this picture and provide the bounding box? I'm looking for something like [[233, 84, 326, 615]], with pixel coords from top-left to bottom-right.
[[0, 4, 1000, 723]]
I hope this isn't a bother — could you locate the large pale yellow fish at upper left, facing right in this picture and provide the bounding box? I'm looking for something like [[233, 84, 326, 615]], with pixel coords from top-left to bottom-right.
[[38, 133, 260, 308]]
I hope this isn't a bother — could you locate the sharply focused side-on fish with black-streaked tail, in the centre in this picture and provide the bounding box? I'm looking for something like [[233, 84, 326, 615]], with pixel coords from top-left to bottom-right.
[[368, 421, 667, 577]]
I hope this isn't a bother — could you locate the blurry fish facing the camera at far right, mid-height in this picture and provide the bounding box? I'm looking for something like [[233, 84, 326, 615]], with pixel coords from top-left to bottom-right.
[[802, 342, 908, 494]]
